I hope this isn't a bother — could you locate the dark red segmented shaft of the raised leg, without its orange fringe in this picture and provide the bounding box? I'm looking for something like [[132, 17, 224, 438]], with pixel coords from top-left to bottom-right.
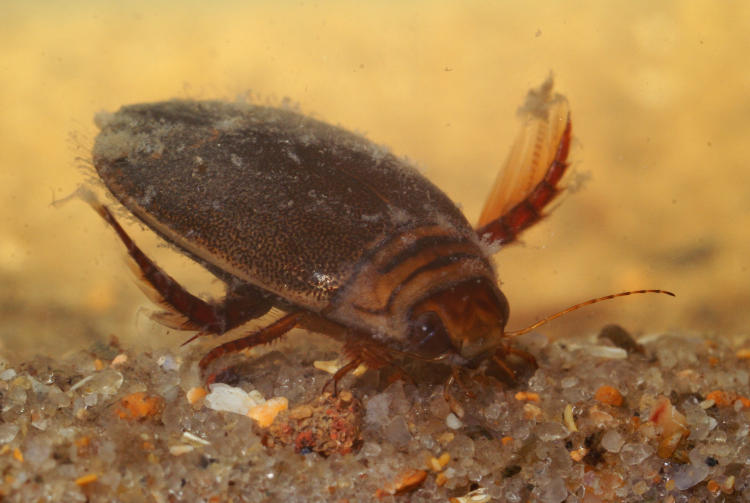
[[477, 116, 571, 245]]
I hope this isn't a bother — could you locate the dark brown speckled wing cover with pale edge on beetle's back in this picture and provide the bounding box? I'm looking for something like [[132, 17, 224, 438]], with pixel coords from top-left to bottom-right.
[[94, 100, 474, 309]]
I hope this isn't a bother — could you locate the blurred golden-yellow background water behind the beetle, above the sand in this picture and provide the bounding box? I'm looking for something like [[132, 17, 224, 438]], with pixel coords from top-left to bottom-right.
[[0, 0, 750, 355]]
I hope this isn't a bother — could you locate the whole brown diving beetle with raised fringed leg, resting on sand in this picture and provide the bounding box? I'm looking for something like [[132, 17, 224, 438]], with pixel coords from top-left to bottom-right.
[[88, 79, 672, 382]]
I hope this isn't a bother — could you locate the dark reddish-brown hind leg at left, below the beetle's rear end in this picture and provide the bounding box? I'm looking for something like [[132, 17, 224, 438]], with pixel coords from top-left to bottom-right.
[[86, 196, 271, 335]]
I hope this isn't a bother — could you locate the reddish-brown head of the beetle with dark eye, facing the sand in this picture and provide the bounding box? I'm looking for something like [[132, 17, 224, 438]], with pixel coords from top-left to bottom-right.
[[410, 279, 509, 364]]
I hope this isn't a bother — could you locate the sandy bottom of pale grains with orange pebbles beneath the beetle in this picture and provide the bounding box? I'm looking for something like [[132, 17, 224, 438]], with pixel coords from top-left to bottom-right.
[[0, 327, 750, 503]]
